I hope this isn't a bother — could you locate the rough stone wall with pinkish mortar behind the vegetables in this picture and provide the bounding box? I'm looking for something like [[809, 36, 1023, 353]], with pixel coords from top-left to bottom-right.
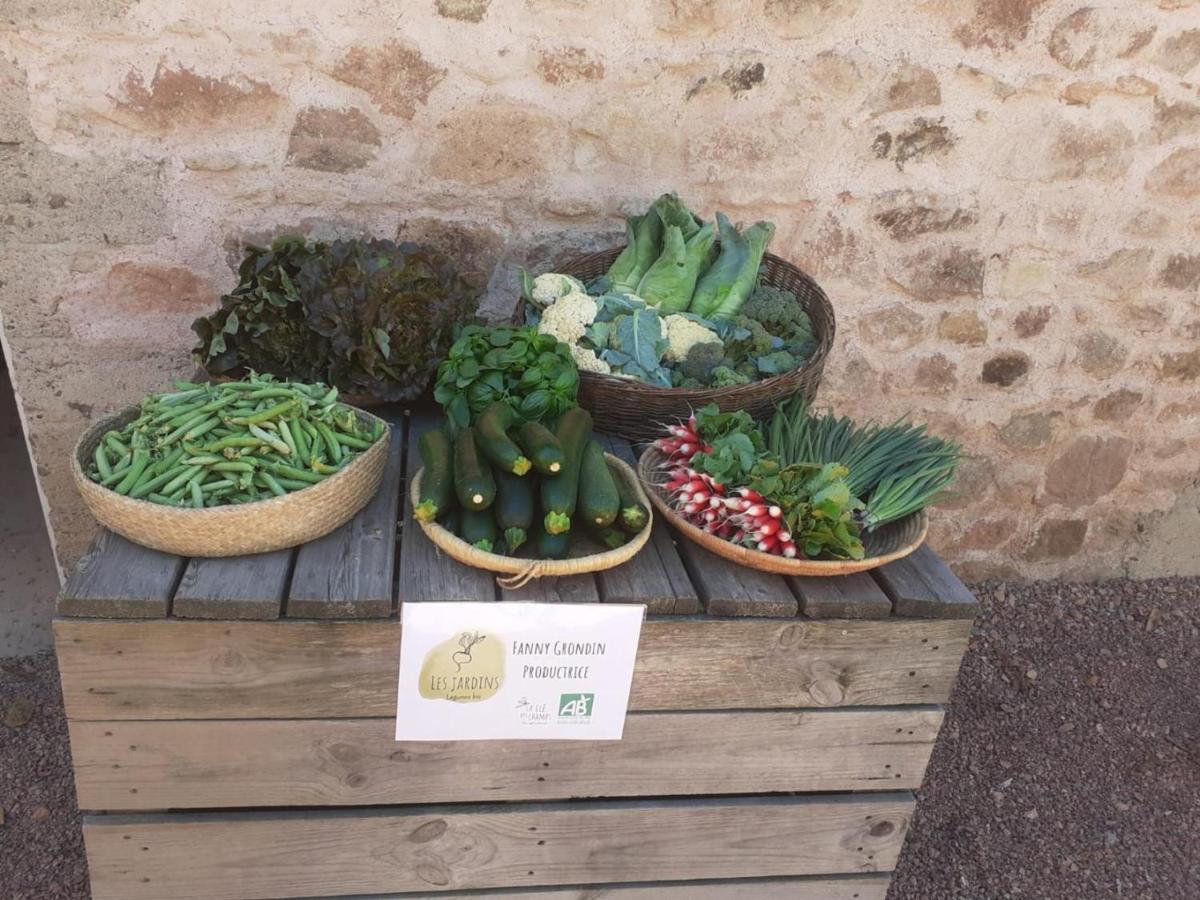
[[0, 0, 1200, 577]]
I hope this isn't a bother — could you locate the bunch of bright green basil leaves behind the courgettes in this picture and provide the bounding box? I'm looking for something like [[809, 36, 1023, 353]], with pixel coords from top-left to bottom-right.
[[433, 325, 580, 428]]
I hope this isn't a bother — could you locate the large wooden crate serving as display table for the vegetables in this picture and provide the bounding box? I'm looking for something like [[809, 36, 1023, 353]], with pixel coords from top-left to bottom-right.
[[55, 412, 976, 900]]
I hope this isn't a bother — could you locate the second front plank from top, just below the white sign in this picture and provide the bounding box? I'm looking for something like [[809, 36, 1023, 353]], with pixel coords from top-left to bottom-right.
[[71, 707, 942, 811]]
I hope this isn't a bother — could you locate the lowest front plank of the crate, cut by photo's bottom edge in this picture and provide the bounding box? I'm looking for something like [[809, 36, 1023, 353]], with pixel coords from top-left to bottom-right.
[[317, 874, 892, 900]]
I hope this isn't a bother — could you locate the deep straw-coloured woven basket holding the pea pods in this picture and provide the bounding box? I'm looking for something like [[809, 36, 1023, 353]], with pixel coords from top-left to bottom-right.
[[71, 407, 391, 557]]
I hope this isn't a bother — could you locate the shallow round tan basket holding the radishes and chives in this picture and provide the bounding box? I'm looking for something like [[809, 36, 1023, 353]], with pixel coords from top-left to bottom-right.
[[637, 448, 929, 576]]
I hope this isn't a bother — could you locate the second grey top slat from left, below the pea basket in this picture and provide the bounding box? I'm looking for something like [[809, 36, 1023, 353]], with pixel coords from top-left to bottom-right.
[[172, 550, 293, 619]]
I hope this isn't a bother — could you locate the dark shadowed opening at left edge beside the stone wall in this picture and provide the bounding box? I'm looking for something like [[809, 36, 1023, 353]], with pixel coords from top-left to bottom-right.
[[0, 343, 59, 658]]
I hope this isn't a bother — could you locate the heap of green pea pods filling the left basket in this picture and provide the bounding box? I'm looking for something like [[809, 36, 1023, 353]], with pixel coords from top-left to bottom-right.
[[88, 376, 383, 508]]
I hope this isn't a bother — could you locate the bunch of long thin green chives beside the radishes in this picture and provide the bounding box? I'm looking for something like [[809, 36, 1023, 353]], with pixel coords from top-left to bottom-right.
[[767, 397, 962, 530]]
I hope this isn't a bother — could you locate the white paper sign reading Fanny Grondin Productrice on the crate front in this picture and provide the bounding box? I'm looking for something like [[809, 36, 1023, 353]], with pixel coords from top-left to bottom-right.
[[396, 602, 646, 740]]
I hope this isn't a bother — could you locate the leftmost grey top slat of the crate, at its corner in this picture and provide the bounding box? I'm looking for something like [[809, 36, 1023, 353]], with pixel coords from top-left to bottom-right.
[[59, 528, 185, 618]]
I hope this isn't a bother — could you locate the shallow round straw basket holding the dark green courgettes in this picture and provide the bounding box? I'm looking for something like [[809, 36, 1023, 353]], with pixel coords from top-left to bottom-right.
[[409, 454, 654, 589]]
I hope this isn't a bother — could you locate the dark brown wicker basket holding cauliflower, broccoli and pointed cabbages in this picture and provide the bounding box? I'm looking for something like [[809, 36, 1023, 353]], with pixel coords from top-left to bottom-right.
[[515, 247, 835, 440]]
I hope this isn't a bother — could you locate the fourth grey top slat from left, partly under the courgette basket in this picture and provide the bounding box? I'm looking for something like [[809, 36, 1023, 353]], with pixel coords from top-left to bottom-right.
[[397, 413, 496, 604]]
